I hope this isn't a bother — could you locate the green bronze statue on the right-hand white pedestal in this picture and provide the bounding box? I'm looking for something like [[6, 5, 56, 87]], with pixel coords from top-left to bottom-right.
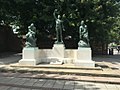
[[78, 21, 90, 47]]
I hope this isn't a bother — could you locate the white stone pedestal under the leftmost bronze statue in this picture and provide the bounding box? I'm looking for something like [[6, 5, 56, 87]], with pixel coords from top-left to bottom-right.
[[19, 47, 39, 65]]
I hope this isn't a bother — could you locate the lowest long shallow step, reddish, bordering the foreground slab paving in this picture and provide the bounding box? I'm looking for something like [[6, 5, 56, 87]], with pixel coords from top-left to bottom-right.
[[0, 72, 120, 84]]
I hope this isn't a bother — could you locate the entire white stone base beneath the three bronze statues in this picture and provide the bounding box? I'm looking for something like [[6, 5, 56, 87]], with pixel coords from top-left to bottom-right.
[[19, 44, 95, 67]]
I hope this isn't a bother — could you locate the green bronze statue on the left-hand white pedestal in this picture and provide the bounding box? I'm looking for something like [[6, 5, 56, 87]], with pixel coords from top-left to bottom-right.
[[26, 23, 36, 47]]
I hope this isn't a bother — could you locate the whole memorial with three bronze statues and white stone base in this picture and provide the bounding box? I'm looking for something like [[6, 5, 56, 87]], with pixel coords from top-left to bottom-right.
[[19, 9, 95, 67]]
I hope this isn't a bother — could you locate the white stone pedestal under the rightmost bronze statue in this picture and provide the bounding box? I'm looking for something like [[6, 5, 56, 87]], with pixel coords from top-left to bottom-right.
[[74, 48, 95, 67]]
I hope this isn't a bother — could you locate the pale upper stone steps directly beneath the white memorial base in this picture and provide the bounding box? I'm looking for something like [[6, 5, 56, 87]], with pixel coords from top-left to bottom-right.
[[0, 65, 120, 78]]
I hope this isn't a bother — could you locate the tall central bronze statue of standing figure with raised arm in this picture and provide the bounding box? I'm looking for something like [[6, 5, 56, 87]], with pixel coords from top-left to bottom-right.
[[53, 9, 64, 44]]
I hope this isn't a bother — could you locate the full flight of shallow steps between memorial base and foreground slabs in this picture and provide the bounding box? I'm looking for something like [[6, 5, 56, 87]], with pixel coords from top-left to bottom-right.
[[0, 64, 120, 84]]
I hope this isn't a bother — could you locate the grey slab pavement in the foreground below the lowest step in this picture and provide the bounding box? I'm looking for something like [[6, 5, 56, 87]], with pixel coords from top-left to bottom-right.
[[0, 72, 120, 90]]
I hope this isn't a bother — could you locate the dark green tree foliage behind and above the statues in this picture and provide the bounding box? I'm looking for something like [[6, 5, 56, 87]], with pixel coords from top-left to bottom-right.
[[0, 0, 120, 43]]
